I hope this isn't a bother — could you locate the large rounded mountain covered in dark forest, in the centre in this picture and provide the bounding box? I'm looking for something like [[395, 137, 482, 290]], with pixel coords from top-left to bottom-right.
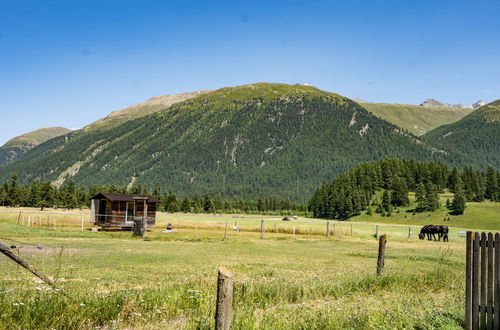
[[0, 83, 476, 201]]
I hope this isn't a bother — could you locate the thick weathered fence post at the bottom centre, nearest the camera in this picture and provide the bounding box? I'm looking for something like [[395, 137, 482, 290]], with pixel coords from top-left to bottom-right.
[[215, 267, 233, 330]]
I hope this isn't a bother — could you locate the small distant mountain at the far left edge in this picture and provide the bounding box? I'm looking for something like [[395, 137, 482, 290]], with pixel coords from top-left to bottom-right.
[[0, 127, 71, 166]]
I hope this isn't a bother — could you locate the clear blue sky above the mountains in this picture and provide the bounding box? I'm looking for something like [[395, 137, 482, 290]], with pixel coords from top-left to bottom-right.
[[0, 0, 500, 144]]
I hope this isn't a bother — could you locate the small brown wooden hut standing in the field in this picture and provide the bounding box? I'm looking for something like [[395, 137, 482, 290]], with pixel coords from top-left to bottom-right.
[[90, 193, 160, 229]]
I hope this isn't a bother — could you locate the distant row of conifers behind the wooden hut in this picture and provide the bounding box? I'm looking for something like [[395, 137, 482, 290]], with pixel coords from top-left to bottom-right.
[[0, 174, 307, 215]]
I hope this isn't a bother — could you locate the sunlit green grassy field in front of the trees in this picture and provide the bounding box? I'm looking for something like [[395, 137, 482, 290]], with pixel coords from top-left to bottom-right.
[[0, 204, 499, 329]]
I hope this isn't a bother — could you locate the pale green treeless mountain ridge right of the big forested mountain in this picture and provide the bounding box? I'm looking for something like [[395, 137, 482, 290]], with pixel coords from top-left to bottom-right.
[[358, 102, 472, 136]]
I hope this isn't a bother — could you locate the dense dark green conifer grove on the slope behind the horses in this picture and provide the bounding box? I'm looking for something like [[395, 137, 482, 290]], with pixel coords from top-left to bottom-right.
[[308, 159, 500, 220]]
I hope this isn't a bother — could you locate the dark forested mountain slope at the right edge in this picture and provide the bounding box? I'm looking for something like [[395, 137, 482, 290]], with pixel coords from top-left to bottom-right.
[[423, 100, 500, 168]]
